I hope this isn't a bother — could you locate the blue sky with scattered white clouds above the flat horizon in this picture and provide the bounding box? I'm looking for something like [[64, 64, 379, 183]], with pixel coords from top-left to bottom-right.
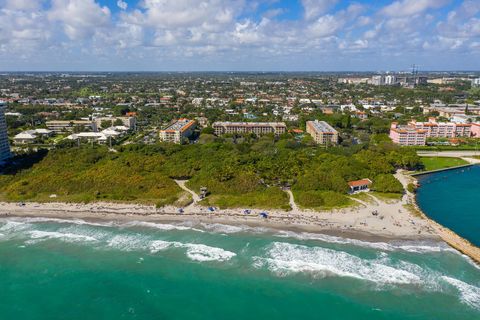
[[0, 0, 480, 71]]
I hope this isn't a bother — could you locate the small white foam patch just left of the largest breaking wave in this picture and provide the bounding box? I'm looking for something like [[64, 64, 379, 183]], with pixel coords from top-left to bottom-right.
[[150, 240, 236, 262]]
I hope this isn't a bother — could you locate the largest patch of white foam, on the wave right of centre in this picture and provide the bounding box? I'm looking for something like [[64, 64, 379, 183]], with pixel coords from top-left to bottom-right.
[[255, 242, 423, 284]]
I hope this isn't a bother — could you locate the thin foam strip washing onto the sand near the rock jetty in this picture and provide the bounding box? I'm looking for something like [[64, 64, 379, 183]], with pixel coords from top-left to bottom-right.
[[276, 231, 457, 253]]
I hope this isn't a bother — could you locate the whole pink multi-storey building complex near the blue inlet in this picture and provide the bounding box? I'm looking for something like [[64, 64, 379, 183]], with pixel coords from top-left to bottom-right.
[[390, 118, 472, 146]]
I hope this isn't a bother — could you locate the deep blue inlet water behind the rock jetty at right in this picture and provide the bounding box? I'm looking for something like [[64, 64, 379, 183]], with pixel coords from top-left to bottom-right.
[[417, 165, 480, 246]]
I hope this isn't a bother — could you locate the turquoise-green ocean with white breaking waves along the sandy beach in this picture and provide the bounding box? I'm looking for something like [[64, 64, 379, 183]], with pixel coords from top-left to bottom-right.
[[0, 217, 480, 320]]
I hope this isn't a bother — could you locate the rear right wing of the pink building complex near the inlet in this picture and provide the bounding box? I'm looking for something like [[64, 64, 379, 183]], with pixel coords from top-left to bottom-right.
[[409, 118, 472, 138]]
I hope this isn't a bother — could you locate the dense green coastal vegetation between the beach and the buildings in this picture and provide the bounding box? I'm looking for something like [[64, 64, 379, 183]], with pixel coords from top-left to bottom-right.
[[0, 136, 420, 208]]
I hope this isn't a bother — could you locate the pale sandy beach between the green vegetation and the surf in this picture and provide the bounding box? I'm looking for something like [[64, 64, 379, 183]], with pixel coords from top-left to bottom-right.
[[0, 191, 441, 241]]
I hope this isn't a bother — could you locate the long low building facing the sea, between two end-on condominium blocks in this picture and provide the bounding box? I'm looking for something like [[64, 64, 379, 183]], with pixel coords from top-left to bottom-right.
[[213, 122, 287, 136]]
